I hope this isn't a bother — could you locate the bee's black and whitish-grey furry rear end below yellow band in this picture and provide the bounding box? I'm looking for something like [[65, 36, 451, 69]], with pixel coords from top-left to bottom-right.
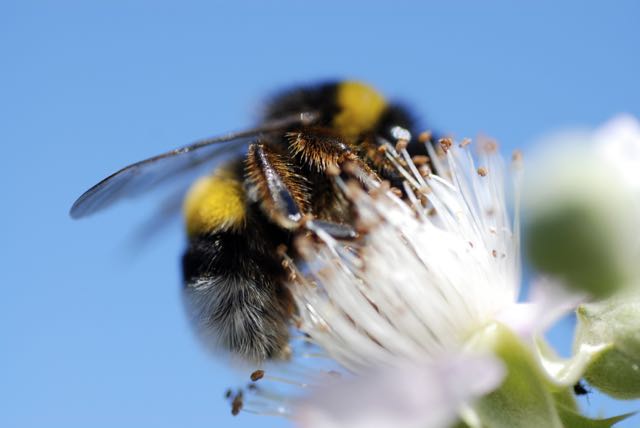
[[183, 227, 291, 361]]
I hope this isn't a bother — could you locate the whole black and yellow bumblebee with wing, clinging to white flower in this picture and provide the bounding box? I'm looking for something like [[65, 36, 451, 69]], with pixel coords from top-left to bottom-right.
[[70, 81, 424, 361]]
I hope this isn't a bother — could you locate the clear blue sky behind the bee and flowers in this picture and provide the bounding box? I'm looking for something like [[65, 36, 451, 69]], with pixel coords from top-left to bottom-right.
[[0, 0, 640, 427]]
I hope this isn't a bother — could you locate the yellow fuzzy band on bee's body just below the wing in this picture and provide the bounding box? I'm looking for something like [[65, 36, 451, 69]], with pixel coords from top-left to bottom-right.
[[183, 169, 246, 236]]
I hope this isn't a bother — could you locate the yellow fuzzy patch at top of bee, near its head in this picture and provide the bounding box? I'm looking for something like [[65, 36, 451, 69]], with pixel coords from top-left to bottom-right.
[[333, 81, 387, 138]]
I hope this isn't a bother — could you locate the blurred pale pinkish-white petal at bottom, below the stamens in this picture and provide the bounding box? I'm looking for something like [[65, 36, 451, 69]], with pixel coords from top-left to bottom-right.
[[294, 356, 505, 428]]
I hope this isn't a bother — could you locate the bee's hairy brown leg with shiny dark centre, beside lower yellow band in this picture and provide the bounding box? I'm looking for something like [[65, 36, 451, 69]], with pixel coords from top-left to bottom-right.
[[246, 142, 309, 229]]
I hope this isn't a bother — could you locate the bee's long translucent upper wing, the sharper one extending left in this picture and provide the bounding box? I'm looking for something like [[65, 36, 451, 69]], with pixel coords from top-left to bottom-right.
[[69, 113, 316, 218]]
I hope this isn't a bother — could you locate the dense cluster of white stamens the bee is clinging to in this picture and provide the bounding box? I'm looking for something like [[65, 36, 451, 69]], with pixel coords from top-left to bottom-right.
[[290, 139, 520, 373]]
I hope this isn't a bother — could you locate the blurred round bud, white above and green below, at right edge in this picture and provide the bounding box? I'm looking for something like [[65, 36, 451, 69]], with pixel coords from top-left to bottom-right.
[[524, 115, 640, 298]]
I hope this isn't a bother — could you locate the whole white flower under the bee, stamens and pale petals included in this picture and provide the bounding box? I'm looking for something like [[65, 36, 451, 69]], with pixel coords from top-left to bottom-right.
[[236, 136, 594, 428]]
